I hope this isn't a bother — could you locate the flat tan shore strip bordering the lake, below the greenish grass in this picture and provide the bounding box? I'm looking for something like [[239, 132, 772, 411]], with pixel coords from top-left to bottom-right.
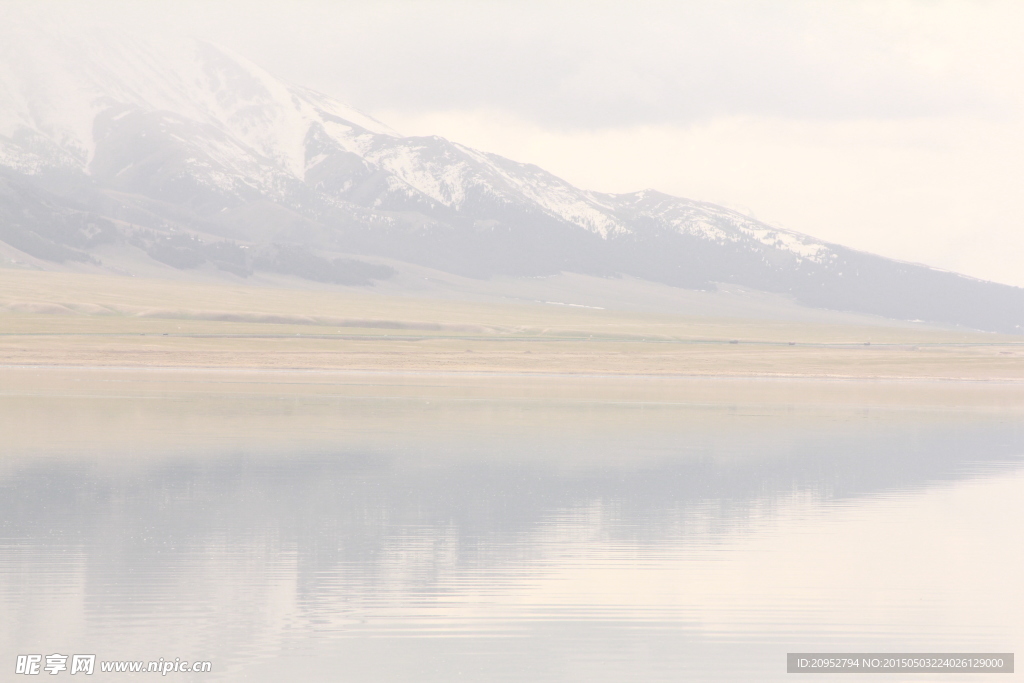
[[0, 334, 1024, 380]]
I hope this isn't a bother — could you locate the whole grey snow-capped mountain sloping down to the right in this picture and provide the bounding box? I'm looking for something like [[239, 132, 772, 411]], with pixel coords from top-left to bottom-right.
[[0, 27, 1024, 331]]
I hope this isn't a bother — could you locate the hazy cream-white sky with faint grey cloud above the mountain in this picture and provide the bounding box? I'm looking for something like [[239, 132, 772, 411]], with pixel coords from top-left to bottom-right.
[[8, 0, 1024, 286]]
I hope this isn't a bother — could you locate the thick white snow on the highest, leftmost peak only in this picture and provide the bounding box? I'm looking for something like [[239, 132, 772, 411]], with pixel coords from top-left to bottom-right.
[[0, 24, 396, 184]]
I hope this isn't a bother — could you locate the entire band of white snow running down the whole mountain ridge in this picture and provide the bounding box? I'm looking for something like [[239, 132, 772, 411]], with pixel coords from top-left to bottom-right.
[[0, 18, 835, 262]]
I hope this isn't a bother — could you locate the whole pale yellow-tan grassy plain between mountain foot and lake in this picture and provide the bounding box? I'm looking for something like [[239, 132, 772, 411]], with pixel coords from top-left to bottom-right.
[[0, 269, 1024, 381]]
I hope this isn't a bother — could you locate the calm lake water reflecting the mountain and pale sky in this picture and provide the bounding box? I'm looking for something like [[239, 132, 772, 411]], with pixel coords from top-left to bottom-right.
[[0, 368, 1024, 682]]
